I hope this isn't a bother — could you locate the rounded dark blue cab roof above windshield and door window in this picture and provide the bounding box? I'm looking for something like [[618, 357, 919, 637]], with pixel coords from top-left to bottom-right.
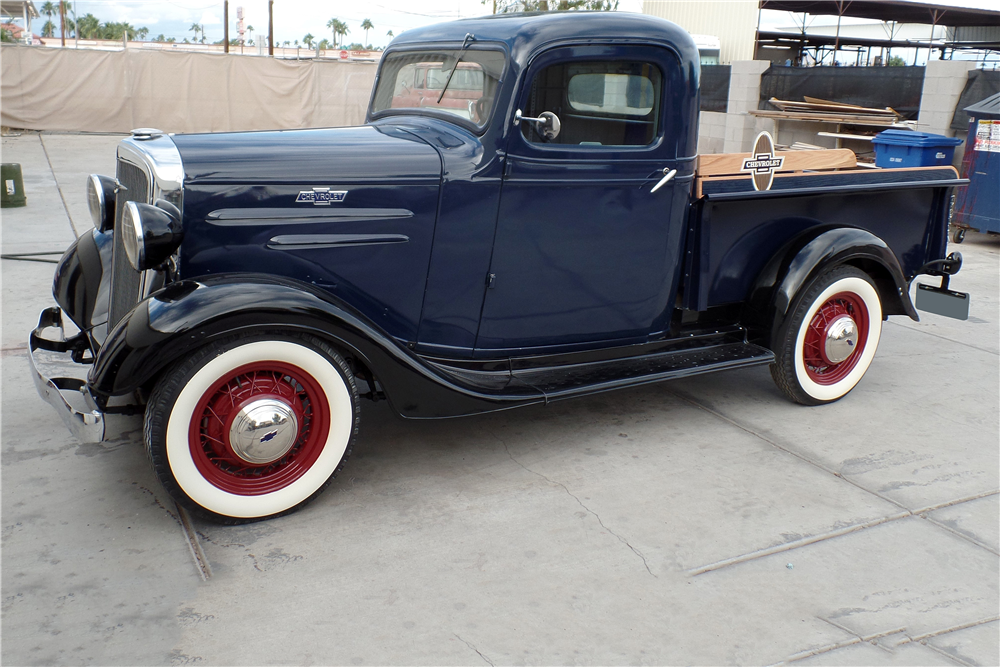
[[390, 11, 698, 65]]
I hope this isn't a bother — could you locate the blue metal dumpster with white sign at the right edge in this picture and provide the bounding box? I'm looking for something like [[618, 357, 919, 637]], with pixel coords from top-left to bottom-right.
[[952, 93, 1000, 243]]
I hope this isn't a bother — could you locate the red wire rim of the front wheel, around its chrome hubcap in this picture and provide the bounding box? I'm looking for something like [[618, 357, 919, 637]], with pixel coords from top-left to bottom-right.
[[188, 361, 330, 496]]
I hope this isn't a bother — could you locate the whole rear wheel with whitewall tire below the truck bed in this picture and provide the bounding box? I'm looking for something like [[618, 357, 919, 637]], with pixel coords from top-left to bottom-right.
[[771, 266, 882, 405]]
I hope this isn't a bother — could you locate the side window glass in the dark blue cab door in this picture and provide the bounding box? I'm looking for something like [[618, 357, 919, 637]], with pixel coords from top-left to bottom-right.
[[521, 60, 663, 146]]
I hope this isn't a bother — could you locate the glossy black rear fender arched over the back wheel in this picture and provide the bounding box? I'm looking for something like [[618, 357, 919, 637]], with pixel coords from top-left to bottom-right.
[[744, 227, 920, 336]]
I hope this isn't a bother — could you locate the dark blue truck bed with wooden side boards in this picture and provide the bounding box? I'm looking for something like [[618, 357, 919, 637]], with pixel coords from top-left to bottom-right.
[[682, 149, 966, 311]]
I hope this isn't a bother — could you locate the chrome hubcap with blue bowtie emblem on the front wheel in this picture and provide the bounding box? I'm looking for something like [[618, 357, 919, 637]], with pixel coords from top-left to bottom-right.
[[229, 398, 299, 465]]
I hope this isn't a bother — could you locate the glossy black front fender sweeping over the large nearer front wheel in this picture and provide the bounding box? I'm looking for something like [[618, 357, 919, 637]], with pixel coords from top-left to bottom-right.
[[88, 274, 543, 418]]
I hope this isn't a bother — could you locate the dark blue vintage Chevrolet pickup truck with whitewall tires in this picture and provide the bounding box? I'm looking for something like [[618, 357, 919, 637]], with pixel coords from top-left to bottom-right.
[[30, 13, 968, 522]]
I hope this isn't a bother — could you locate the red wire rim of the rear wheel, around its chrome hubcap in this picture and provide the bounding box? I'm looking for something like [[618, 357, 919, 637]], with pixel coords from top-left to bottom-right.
[[802, 292, 869, 385]]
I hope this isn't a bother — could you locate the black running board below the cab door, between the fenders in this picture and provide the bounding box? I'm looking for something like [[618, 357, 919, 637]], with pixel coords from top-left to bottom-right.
[[433, 342, 774, 402]]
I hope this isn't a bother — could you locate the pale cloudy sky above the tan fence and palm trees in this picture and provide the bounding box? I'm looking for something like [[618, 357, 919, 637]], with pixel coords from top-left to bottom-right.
[[32, 0, 998, 47]]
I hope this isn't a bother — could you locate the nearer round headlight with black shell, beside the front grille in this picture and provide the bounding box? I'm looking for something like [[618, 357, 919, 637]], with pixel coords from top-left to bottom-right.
[[118, 199, 184, 271]]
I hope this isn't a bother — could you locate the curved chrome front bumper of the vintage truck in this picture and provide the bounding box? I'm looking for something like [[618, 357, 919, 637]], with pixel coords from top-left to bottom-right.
[[28, 307, 105, 442]]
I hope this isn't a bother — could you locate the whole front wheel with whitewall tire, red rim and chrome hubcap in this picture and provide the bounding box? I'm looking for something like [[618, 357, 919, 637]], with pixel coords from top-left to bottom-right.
[[144, 334, 360, 523]]
